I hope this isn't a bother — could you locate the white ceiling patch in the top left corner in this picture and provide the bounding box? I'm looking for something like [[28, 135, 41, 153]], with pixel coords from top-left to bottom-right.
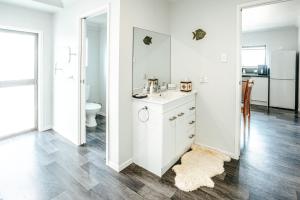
[[0, 0, 78, 13]]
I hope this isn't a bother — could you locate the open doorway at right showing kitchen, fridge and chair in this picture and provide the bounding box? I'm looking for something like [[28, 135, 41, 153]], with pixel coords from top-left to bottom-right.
[[237, 0, 300, 152]]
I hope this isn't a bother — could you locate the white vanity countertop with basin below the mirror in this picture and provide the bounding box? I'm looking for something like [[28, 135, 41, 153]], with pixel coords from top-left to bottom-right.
[[133, 90, 197, 104]]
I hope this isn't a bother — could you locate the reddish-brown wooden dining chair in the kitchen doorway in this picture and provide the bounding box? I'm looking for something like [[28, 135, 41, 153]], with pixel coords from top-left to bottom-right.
[[241, 79, 254, 130]]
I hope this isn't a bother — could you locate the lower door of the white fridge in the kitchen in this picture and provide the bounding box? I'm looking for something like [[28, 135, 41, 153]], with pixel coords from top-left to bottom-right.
[[270, 79, 295, 109]]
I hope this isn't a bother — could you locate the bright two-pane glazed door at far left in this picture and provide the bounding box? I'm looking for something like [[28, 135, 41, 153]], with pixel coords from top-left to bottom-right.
[[0, 29, 38, 138]]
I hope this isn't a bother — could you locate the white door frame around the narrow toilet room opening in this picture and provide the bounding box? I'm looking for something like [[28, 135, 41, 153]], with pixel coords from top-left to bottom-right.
[[78, 3, 110, 165]]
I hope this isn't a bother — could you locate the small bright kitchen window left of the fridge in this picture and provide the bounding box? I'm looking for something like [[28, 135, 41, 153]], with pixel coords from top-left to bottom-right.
[[242, 46, 266, 67]]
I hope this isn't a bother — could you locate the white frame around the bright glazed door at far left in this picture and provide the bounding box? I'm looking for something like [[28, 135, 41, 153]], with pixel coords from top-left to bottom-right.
[[0, 25, 43, 138]]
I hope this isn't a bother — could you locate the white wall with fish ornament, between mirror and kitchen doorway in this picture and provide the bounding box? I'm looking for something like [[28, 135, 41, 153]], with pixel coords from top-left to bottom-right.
[[170, 0, 256, 157]]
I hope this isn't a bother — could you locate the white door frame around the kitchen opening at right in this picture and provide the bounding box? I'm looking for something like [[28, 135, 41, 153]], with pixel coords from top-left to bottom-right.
[[234, 0, 293, 159]]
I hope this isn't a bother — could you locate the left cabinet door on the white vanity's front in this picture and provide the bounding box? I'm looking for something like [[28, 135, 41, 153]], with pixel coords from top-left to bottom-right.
[[162, 111, 177, 166]]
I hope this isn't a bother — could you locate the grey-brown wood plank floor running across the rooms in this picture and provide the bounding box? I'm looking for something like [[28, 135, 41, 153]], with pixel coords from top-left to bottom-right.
[[0, 109, 300, 200]]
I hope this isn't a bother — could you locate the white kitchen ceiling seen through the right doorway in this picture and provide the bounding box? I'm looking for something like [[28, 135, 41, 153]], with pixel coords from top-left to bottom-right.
[[242, 0, 300, 32]]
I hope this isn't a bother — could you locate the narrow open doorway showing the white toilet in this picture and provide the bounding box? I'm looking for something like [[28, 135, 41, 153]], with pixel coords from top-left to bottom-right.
[[80, 9, 109, 161]]
